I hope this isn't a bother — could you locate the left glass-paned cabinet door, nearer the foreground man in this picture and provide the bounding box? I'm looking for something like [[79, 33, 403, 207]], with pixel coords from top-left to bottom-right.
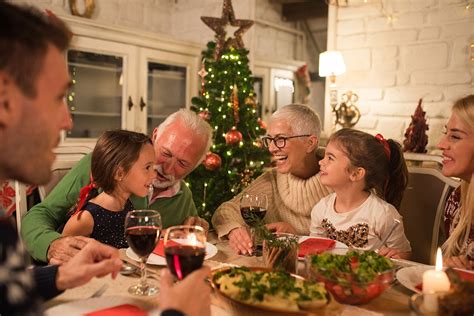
[[66, 37, 137, 139]]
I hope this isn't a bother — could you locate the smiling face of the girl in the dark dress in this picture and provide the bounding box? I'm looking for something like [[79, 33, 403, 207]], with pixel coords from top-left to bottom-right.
[[119, 144, 155, 197]]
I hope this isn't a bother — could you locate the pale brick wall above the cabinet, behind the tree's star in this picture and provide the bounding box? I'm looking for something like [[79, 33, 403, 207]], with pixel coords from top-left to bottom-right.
[[12, 0, 301, 60]]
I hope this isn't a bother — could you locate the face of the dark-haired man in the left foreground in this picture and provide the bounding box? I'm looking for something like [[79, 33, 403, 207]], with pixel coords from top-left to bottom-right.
[[0, 45, 72, 184]]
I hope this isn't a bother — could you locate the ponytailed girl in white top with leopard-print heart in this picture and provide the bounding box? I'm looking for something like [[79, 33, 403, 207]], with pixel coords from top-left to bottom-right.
[[310, 129, 411, 258]]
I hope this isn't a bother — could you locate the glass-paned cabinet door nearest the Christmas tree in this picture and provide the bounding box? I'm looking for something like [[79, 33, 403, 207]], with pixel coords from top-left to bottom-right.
[[136, 48, 198, 135]]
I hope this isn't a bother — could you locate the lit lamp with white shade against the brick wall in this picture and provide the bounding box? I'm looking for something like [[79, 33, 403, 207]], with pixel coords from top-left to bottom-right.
[[319, 51, 346, 123]]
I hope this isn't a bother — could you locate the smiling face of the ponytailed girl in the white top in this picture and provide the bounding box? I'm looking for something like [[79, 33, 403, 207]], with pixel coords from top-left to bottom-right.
[[319, 141, 351, 189]]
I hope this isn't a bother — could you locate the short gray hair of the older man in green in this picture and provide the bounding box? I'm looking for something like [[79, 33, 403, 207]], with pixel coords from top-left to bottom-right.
[[156, 109, 212, 164]]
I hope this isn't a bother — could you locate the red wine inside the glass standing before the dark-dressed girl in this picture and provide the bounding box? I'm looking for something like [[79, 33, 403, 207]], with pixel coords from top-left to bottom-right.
[[125, 226, 160, 257]]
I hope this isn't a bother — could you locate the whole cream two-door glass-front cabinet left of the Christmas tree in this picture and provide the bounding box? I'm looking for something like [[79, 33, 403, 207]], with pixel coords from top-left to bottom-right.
[[63, 16, 201, 143]]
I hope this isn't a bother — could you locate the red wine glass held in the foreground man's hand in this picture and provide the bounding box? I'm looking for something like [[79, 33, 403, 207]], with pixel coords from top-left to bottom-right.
[[163, 225, 206, 281]]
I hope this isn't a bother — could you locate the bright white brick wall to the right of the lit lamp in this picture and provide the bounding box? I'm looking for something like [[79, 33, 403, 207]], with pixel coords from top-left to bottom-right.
[[332, 0, 474, 147]]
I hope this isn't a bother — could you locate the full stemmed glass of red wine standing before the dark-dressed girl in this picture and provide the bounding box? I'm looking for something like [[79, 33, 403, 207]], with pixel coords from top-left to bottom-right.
[[125, 210, 161, 296]]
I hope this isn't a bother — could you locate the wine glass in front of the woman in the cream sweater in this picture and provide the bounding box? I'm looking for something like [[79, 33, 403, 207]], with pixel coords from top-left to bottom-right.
[[240, 193, 268, 256]]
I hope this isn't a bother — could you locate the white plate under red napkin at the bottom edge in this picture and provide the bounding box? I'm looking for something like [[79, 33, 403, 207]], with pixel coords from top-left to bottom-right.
[[45, 296, 160, 316]]
